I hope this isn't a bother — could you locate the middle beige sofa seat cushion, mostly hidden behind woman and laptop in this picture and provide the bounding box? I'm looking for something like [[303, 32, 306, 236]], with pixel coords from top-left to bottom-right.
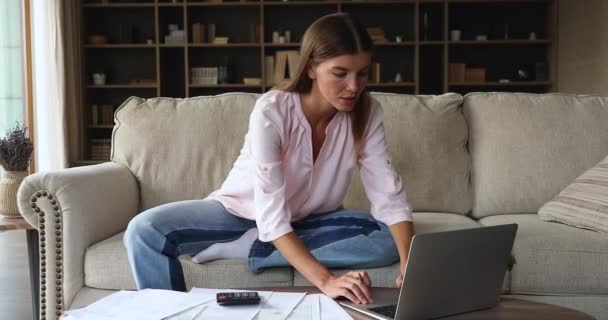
[[293, 212, 481, 287]]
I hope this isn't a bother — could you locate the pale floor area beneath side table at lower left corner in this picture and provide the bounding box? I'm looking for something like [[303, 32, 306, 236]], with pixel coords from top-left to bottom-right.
[[0, 230, 33, 320]]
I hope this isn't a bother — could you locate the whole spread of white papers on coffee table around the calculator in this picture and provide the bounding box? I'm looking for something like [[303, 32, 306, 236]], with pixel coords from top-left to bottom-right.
[[62, 288, 352, 320]]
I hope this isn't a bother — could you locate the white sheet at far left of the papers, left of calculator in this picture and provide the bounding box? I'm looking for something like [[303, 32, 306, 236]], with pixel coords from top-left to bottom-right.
[[64, 289, 215, 320]]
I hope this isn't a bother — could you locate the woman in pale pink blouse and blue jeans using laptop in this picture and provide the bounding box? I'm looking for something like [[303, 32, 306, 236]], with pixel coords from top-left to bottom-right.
[[124, 14, 414, 303]]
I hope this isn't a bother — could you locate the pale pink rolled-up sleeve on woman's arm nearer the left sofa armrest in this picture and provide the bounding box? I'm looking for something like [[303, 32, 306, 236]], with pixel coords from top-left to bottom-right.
[[249, 101, 293, 242]]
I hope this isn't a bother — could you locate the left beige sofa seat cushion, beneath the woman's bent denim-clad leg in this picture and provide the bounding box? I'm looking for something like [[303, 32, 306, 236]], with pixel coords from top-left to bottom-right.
[[84, 232, 293, 290]]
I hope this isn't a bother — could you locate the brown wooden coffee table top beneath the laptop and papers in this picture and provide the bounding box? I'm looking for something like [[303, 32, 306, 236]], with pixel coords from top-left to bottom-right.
[[241, 287, 593, 320]]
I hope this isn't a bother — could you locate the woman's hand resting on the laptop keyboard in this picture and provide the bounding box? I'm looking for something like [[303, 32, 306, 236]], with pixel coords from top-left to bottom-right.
[[319, 271, 373, 304]]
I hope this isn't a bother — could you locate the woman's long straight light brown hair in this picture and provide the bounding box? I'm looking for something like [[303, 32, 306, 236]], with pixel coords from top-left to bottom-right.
[[275, 13, 373, 159]]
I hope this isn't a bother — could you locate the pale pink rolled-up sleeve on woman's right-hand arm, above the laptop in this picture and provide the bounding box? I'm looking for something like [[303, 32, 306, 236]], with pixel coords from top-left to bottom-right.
[[359, 100, 413, 226]]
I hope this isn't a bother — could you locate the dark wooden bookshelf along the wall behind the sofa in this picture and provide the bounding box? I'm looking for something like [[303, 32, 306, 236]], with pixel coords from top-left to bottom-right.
[[78, 0, 558, 165]]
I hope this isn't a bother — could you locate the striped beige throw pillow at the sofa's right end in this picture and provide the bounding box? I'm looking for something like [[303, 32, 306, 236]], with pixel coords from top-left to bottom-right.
[[538, 157, 608, 234]]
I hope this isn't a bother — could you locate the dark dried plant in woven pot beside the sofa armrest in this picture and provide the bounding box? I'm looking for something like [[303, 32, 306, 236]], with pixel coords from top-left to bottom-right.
[[0, 123, 34, 218]]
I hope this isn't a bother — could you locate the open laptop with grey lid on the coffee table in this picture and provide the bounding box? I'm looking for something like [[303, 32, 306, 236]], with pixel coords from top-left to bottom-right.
[[339, 224, 517, 320]]
